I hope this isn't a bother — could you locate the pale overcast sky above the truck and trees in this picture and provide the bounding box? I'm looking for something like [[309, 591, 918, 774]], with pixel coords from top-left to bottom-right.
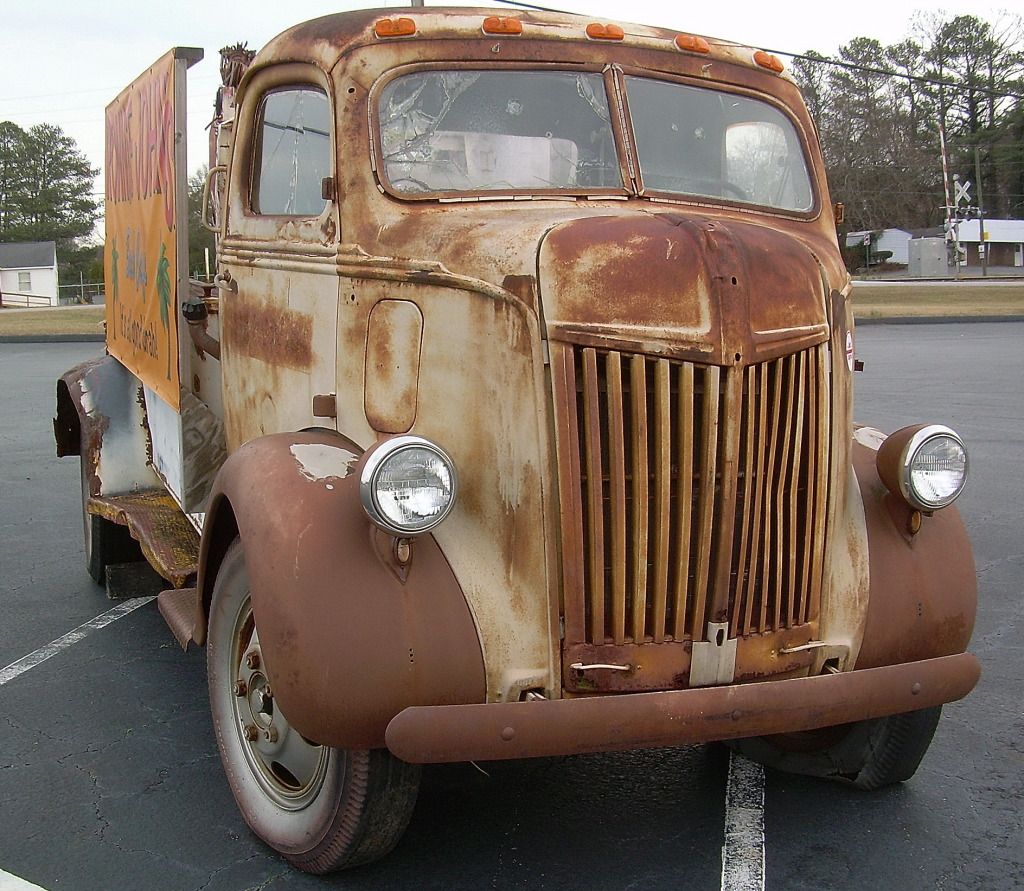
[[0, 0, 1024, 218]]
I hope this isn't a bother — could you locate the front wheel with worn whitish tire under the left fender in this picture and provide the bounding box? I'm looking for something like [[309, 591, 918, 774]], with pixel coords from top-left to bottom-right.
[[207, 541, 420, 874]]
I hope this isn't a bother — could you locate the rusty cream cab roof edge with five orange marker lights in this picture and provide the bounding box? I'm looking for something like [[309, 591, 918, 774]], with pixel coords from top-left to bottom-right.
[[250, 6, 788, 79]]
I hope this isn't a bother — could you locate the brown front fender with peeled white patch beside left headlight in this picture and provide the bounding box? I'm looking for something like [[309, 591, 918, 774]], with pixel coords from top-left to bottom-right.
[[196, 432, 485, 749]]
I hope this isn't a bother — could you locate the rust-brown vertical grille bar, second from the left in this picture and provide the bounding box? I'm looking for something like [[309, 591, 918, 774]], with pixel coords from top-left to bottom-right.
[[583, 349, 604, 643]]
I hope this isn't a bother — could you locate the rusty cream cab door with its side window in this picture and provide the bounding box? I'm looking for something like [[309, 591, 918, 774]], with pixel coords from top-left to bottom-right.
[[218, 65, 338, 451]]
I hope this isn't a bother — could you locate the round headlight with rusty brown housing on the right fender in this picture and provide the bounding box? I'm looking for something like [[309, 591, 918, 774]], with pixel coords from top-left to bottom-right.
[[878, 424, 968, 511]]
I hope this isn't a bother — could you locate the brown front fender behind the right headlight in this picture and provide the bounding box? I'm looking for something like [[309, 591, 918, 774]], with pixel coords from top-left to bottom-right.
[[852, 428, 978, 669]]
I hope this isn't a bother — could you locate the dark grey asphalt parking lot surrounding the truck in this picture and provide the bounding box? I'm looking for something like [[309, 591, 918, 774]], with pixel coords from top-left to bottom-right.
[[0, 323, 1024, 891]]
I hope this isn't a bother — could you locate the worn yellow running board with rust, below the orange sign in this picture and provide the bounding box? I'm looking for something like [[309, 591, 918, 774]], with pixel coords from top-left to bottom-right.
[[88, 489, 199, 588]]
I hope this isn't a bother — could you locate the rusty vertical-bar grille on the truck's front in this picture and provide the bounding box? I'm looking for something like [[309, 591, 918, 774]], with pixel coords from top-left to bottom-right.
[[552, 344, 829, 645]]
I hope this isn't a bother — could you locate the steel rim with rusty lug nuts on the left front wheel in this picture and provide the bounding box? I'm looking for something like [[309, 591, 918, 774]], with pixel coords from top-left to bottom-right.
[[227, 597, 331, 811]]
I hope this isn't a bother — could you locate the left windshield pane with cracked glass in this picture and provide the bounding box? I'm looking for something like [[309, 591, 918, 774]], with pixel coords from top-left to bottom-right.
[[379, 70, 624, 194]]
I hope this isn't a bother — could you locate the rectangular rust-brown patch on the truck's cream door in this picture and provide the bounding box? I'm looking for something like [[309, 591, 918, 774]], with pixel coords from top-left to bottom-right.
[[224, 300, 313, 372]]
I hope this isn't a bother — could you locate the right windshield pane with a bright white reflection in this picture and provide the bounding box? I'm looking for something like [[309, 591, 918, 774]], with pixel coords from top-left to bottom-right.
[[626, 77, 814, 212]]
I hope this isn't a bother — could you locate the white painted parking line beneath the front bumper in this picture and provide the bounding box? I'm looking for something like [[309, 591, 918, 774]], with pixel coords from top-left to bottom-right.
[[722, 752, 765, 891]]
